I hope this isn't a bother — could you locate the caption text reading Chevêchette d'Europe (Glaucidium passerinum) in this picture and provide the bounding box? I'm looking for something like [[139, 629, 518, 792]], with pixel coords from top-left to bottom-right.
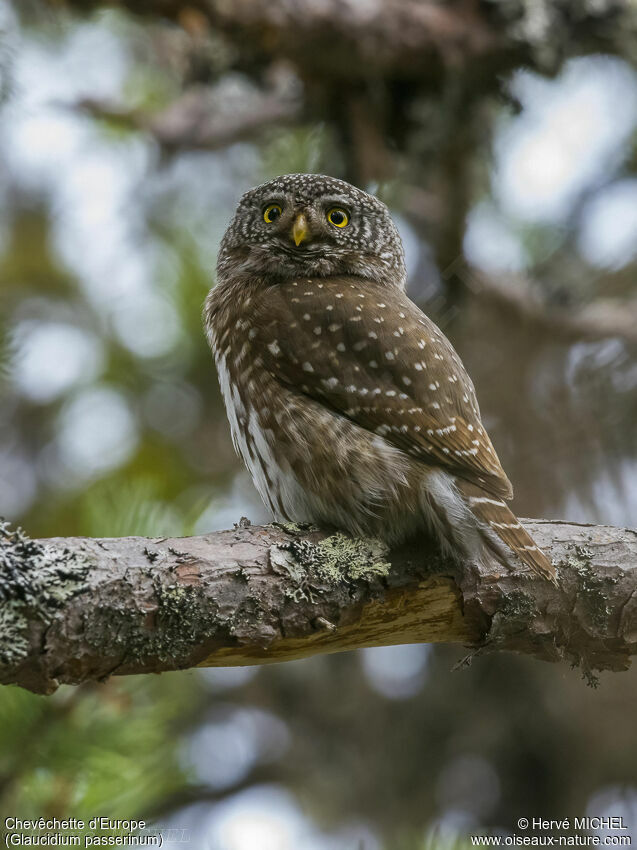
[[4, 816, 164, 847]]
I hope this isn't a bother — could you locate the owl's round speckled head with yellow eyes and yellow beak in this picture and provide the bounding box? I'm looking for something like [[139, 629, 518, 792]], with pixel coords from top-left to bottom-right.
[[217, 174, 405, 288]]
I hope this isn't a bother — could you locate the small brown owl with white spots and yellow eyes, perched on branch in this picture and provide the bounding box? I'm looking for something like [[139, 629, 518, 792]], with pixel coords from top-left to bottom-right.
[[204, 174, 554, 578]]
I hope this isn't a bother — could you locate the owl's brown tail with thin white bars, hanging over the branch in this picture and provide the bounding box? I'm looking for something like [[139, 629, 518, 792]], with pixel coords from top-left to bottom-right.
[[461, 482, 555, 582]]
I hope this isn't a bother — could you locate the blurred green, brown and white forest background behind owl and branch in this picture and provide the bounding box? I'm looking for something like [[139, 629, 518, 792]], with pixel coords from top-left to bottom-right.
[[0, 0, 637, 850]]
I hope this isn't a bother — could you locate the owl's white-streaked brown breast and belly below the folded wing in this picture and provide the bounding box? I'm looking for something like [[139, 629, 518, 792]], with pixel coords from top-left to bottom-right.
[[211, 332, 424, 536]]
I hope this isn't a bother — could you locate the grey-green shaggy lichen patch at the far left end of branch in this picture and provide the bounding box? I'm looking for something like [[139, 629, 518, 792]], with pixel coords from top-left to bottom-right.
[[0, 520, 90, 664]]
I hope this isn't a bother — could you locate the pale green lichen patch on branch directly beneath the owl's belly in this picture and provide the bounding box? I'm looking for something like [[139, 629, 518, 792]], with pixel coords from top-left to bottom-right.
[[270, 532, 391, 602]]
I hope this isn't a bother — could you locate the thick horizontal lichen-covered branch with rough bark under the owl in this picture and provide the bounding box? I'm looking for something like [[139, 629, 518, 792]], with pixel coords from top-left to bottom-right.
[[0, 520, 637, 693]]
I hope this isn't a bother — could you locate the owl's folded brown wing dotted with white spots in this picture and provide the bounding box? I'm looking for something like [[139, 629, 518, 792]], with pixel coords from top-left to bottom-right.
[[250, 278, 513, 498]]
